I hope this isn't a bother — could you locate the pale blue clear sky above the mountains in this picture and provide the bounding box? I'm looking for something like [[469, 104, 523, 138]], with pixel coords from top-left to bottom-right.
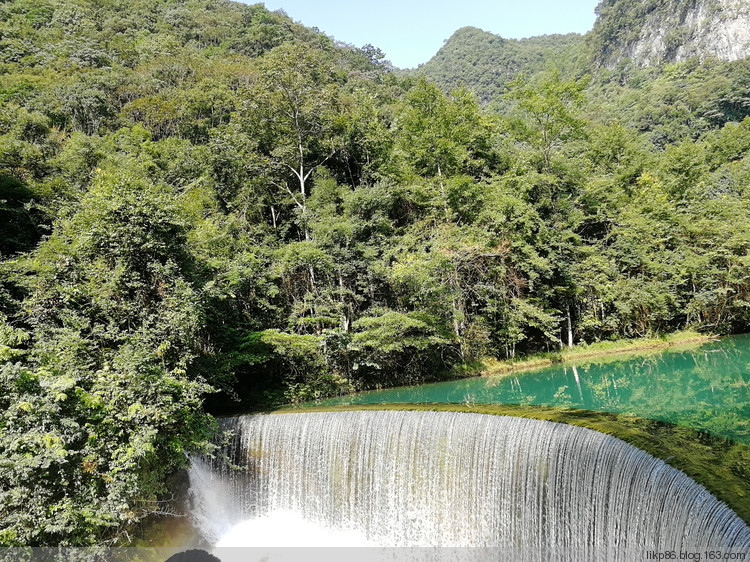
[[253, 0, 598, 68]]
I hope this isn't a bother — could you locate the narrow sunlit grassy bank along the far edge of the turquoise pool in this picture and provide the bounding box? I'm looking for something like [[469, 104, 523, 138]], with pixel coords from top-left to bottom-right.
[[470, 331, 716, 376]]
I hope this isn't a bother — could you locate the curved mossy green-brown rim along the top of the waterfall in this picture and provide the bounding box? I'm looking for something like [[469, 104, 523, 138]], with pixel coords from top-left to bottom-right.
[[280, 404, 750, 524]]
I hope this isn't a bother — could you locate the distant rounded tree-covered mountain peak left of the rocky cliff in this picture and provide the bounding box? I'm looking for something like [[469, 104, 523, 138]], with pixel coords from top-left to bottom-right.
[[414, 27, 583, 102]]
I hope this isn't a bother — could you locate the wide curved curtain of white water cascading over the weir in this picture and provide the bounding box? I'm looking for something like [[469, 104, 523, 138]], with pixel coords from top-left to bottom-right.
[[190, 411, 750, 560]]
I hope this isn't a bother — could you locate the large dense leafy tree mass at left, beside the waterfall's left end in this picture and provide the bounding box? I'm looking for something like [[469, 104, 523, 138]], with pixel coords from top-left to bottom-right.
[[0, 169, 210, 545]]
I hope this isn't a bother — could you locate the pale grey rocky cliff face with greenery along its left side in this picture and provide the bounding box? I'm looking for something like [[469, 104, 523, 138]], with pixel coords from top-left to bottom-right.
[[589, 0, 750, 68]]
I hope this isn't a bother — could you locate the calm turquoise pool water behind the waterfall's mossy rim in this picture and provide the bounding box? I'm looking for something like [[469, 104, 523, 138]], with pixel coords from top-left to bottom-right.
[[317, 334, 750, 445]]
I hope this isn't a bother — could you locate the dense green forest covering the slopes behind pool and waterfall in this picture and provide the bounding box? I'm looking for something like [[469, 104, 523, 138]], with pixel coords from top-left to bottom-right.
[[0, 0, 750, 546]]
